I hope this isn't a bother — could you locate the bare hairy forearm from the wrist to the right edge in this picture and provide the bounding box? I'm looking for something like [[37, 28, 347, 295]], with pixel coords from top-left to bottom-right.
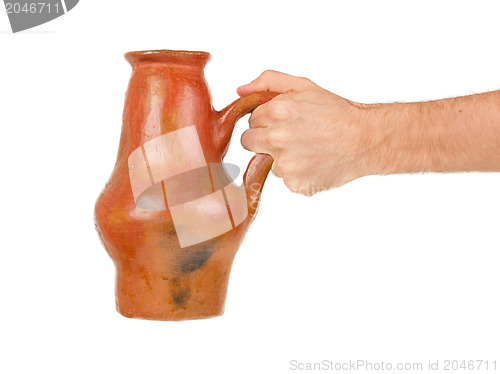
[[361, 91, 500, 174]]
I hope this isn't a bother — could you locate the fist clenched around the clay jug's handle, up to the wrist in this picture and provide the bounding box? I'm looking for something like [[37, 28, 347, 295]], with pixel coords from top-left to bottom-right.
[[238, 70, 372, 196]]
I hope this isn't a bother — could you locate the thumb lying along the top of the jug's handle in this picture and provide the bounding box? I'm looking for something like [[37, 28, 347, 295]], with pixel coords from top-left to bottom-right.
[[237, 70, 314, 96]]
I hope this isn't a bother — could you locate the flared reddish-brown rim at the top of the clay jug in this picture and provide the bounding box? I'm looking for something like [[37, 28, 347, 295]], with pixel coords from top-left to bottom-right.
[[125, 49, 210, 67]]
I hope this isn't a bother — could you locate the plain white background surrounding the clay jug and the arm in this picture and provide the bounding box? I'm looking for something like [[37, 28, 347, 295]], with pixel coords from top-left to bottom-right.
[[0, 0, 500, 374]]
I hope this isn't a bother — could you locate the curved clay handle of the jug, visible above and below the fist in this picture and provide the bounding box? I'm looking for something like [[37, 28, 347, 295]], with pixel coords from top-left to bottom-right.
[[216, 91, 279, 216]]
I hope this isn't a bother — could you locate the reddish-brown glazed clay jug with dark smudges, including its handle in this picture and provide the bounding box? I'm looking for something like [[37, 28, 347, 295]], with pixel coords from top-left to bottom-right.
[[95, 50, 276, 320]]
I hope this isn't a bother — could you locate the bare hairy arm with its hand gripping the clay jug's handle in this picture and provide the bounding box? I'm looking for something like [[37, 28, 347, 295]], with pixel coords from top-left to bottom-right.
[[238, 71, 500, 195]]
